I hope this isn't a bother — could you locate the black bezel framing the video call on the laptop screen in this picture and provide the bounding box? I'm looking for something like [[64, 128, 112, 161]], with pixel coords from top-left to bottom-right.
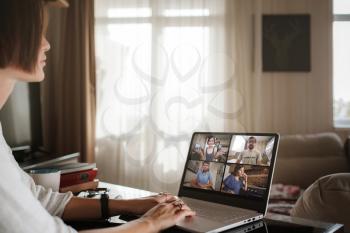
[[178, 132, 280, 215]]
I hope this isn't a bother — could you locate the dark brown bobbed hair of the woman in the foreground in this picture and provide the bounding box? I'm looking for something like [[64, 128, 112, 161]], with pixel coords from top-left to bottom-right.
[[0, 0, 44, 72]]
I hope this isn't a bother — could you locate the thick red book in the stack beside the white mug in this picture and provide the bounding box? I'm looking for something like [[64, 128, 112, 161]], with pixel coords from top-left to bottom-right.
[[60, 168, 97, 188]]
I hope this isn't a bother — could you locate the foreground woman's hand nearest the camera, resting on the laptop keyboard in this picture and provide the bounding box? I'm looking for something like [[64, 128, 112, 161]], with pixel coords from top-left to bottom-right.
[[141, 200, 196, 232]]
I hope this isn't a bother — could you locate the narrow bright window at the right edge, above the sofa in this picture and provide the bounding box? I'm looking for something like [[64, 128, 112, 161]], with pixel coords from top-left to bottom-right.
[[333, 0, 350, 128]]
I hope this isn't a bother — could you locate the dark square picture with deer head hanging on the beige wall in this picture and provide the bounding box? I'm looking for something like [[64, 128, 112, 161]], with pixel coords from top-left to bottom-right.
[[262, 14, 311, 72]]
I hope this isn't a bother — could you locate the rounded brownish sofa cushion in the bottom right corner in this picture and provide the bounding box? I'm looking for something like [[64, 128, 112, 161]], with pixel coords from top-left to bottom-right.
[[291, 173, 350, 232]]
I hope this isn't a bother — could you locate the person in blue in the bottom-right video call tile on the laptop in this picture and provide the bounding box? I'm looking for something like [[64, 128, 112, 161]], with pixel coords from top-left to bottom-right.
[[223, 165, 248, 194]]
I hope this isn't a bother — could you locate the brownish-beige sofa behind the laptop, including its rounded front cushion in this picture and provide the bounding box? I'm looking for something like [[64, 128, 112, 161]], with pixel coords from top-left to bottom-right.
[[269, 132, 350, 232]]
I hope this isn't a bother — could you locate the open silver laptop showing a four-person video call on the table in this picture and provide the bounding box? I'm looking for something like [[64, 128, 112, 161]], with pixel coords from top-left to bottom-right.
[[176, 132, 279, 232]]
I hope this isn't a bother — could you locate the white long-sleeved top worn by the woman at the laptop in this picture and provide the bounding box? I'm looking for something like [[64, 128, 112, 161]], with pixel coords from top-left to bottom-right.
[[0, 124, 76, 233]]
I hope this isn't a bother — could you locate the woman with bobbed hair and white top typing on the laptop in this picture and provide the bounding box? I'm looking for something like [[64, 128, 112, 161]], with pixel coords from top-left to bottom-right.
[[0, 0, 194, 233]]
